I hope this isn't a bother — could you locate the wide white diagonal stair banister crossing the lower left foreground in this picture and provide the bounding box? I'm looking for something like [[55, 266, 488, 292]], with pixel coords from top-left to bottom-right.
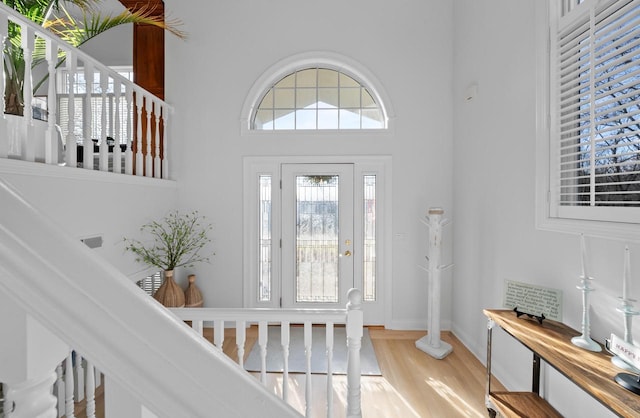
[[0, 179, 299, 417]]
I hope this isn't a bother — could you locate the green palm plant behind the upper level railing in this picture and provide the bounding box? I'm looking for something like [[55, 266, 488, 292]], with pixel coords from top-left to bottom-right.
[[2, 0, 185, 115]]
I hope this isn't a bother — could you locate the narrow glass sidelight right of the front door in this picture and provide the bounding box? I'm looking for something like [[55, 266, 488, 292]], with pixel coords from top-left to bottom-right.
[[362, 175, 376, 302]]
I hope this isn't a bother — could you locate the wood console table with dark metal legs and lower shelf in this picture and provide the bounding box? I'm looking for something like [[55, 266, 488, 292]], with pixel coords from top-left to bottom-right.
[[483, 309, 640, 418]]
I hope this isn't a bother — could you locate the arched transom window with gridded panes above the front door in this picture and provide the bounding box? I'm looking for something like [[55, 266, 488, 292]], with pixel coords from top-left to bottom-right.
[[251, 68, 386, 130]]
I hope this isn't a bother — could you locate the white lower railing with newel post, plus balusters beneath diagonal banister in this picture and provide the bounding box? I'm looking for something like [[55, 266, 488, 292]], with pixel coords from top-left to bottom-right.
[[42, 289, 363, 418]]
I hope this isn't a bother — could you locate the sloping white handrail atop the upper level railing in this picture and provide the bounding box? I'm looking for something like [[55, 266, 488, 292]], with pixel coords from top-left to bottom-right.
[[0, 3, 173, 112]]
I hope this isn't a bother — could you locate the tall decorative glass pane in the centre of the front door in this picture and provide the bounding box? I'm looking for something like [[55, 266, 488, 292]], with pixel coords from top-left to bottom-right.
[[296, 175, 339, 303]]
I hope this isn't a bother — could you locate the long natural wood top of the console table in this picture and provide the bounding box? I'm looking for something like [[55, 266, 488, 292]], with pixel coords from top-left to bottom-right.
[[484, 309, 640, 417]]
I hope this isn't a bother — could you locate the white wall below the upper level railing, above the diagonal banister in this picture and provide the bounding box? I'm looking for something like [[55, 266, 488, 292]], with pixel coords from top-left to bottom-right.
[[0, 159, 178, 280]]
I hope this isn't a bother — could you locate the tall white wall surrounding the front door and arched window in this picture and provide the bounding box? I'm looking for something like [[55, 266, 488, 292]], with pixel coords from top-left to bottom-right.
[[165, 0, 453, 328]]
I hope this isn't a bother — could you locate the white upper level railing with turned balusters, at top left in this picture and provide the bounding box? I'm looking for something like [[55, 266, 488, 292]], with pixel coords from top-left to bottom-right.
[[0, 3, 172, 179]]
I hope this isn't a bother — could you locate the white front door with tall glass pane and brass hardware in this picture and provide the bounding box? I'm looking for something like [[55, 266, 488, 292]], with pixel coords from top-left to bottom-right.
[[280, 163, 361, 308]]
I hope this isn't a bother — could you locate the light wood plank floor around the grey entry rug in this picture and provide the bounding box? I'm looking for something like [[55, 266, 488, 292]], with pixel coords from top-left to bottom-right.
[[76, 327, 504, 418]]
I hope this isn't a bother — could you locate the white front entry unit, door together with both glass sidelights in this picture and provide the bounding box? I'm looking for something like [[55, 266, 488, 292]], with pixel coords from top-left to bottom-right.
[[243, 156, 391, 325]]
